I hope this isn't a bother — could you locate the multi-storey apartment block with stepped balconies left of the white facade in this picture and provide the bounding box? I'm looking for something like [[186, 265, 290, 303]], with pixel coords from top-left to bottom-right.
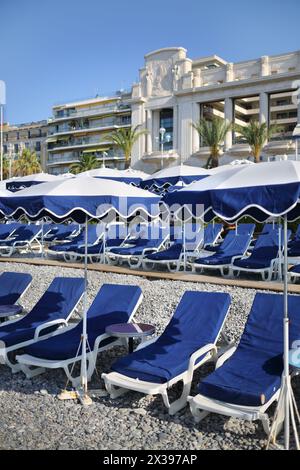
[[47, 91, 131, 174]]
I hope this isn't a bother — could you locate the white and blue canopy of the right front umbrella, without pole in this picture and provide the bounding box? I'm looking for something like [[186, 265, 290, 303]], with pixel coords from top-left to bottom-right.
[[163, 161, 300, 221]]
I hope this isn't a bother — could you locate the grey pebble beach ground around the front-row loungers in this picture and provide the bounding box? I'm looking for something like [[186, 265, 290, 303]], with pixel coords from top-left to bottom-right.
[[0, 263, 299, 450]]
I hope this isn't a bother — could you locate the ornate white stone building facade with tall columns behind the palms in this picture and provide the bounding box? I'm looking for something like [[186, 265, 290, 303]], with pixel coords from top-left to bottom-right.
[[130, 47, 300, 173]]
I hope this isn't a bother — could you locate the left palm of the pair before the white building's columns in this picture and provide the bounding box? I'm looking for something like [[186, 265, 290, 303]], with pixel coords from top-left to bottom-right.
[[192, 116, 231, 168]]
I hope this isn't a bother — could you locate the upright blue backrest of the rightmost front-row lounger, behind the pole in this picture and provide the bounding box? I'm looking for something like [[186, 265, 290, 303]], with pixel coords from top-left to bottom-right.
[[238, 293, 300, 356]]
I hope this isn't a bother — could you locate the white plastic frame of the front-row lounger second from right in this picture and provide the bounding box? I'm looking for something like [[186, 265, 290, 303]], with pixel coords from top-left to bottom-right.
[[102, 306, 230, 415]]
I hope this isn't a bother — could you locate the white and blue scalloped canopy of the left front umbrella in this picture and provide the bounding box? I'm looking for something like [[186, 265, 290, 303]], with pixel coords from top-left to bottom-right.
[[0, 177, 160, 223]]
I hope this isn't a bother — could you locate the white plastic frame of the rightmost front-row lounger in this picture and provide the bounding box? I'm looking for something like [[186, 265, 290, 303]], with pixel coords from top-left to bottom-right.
[[188, 347, 280, 434]]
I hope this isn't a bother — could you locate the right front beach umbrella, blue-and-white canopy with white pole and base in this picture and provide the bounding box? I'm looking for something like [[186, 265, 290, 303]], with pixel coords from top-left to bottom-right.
[[164, 161, 300, 449]]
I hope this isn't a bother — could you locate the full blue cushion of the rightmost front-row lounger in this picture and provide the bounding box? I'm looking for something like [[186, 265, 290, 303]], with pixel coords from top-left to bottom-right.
[[199, 293, 300, 406]]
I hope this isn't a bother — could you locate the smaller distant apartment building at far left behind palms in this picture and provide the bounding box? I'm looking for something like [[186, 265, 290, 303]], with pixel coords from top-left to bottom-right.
[[3, 120, 48, 171]]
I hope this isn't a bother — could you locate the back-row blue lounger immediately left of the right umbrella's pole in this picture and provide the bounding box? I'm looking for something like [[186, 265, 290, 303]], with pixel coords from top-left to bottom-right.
[[230, 230, 291, 281]]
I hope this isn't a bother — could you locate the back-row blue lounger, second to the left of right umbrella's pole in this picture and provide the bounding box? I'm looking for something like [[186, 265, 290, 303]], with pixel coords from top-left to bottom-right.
[[191, 233, 251, 276]]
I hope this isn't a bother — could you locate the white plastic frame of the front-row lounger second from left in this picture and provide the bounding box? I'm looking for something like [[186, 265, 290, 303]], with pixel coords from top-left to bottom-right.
[[0, 293, 83, 374]]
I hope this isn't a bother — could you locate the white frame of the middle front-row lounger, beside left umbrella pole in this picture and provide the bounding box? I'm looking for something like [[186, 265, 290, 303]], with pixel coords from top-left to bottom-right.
[[16, 293, 143, 388]]
